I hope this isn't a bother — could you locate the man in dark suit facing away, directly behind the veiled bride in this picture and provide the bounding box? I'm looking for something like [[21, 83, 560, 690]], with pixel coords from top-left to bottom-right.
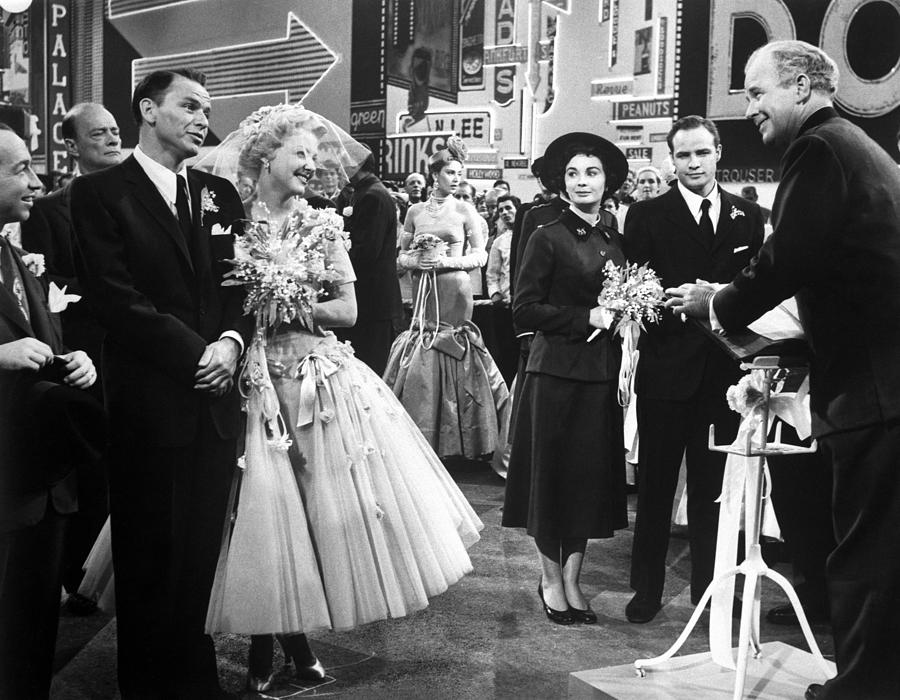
[[338, 155, 403, 377]]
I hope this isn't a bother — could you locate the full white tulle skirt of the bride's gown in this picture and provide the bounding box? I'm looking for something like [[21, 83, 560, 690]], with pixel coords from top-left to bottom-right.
[[207, 331, 483, 634]]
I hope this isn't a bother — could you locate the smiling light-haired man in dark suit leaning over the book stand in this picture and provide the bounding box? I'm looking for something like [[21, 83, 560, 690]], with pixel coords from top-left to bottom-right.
[[676, 41, 900, 700]]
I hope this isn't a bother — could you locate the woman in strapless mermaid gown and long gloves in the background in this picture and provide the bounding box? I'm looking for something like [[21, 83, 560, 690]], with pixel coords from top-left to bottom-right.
[[384, 140, 510, 459]]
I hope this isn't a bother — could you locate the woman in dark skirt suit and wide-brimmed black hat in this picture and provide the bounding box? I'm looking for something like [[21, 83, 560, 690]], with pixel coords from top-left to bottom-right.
[[503, 132, 628, 625]]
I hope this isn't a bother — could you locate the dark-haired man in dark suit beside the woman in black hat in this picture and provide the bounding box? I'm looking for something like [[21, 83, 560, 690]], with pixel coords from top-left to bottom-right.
[[625, 116, 763, 622]]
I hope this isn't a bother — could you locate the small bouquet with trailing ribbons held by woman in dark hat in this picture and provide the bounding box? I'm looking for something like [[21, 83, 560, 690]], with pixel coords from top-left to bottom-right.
[[588, 260, 665, 406]]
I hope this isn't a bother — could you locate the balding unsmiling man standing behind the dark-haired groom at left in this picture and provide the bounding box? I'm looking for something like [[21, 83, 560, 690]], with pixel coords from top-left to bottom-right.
[[22, 102, 122, 615]]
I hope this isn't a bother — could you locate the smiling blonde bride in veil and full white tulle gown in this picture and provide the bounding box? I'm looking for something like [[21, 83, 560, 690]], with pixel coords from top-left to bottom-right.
[[192, 105, 483, 690]]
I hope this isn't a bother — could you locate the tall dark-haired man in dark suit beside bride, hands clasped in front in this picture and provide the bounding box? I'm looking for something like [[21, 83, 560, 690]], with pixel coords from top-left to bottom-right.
[[71, 69, 250, 699]]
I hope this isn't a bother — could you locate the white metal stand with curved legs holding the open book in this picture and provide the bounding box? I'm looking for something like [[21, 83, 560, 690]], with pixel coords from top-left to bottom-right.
[[634, 357, 833, 700]]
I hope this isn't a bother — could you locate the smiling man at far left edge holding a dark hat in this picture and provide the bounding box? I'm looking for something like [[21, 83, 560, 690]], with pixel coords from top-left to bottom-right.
[[0, 125, 105, 698]]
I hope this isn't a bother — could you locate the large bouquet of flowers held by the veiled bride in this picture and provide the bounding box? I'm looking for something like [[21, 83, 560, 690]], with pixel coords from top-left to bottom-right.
[[222, 199, 345, 330]]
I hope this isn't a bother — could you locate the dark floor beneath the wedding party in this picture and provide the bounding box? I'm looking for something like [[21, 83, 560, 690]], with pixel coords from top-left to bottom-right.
[[52, 463, 833, 700]]
